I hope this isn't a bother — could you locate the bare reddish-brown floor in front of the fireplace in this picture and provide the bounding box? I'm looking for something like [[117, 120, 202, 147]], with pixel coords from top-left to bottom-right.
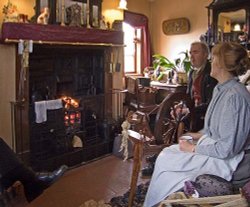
[[24, 155, 148, 207]]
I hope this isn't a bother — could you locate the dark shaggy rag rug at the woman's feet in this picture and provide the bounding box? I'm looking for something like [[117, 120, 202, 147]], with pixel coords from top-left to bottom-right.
[[109, 181, 149, 207]]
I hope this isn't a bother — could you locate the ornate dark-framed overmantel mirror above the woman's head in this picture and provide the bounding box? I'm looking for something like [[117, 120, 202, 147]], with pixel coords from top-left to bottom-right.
[[206, 0, 250, 49]]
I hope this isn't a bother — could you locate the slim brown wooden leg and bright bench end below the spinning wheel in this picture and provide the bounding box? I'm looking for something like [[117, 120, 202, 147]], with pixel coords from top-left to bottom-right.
[[128, 130, 143, 207]]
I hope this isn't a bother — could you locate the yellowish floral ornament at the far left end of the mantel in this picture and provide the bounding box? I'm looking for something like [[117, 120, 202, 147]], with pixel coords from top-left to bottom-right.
[[3, 0, 19, 22]]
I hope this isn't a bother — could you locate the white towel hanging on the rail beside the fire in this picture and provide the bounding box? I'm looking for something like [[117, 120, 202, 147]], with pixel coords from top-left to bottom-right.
[[35, 99, 63, 123]]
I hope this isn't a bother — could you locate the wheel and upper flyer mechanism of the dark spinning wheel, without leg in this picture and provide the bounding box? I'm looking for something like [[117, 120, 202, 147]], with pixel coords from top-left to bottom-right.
[[126, 92, 194, 146]]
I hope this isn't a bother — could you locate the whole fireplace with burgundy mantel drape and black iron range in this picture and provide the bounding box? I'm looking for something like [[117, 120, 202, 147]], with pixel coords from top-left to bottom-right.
[[1, 23, 123, 170]]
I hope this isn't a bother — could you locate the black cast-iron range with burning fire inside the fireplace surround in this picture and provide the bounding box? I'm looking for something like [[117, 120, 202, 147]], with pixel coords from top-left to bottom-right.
[[29, 45, 115, 170]]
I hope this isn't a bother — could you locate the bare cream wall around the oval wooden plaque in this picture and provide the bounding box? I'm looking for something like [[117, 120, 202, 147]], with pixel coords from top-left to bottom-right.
[[151, 0, 212, 60]]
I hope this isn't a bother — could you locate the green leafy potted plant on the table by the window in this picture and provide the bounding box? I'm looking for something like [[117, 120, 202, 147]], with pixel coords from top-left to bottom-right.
[[153, 51, 191, 84]]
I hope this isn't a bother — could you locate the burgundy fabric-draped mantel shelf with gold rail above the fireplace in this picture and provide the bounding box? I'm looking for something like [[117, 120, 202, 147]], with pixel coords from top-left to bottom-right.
[[1, 22, 123, 46]]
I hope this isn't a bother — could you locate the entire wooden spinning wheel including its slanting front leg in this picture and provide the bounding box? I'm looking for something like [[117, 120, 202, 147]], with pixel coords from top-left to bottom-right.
[[127, 92, 193, 207]]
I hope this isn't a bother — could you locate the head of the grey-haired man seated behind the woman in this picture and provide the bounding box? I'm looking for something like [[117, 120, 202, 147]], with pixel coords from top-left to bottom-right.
[[190, 42, 209, 68]]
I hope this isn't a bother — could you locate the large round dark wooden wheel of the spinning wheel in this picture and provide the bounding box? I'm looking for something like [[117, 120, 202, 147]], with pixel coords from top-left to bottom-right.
[[154, 92, 194, 145]]
